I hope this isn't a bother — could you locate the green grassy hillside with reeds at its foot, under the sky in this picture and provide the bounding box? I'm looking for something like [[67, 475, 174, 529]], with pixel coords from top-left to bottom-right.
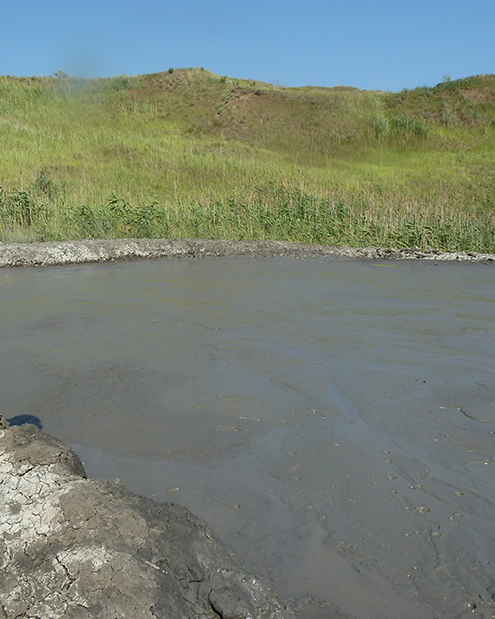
[[0, 69, 495, 252]]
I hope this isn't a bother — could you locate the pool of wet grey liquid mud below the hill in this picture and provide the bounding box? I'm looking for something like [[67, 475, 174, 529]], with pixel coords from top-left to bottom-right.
[[0, 258, 495, 619]]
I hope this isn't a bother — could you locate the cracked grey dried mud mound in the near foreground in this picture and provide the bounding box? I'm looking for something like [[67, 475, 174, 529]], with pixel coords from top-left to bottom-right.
[[0, 416, 293, 619]]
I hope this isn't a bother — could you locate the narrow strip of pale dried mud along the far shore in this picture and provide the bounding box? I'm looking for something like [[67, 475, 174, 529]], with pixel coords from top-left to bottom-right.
[[0, 239, 495, 267]]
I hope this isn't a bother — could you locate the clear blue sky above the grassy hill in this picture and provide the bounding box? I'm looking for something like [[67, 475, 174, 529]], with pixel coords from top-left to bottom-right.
[[0, 0, 495, 91]]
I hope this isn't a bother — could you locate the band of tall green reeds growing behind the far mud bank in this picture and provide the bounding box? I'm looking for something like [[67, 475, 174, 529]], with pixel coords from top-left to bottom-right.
[[0, 177, 495, 253]]
